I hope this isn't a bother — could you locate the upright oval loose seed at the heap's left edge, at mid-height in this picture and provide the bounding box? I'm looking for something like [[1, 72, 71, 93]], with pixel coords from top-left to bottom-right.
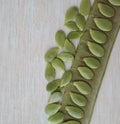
[[45, 63, 56, 81]]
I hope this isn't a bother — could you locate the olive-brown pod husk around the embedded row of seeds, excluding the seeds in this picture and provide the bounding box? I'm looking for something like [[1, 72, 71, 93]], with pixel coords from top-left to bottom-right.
[[62, 0, 120, 124]]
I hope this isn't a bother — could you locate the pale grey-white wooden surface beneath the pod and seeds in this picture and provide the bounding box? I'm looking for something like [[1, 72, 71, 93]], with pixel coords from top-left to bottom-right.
[[0, 0, 120, 124]]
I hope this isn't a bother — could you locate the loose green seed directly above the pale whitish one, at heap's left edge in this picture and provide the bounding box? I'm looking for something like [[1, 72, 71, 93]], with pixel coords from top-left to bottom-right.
[[46, 79, 61, 92]]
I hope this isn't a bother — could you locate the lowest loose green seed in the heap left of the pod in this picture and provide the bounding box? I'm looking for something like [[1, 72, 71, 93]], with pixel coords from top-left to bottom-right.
[[48, 112, 64, 124]]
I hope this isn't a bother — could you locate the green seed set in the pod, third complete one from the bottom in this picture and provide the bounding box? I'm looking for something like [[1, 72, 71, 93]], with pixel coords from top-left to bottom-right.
[[73, 81, 91, 95]]
